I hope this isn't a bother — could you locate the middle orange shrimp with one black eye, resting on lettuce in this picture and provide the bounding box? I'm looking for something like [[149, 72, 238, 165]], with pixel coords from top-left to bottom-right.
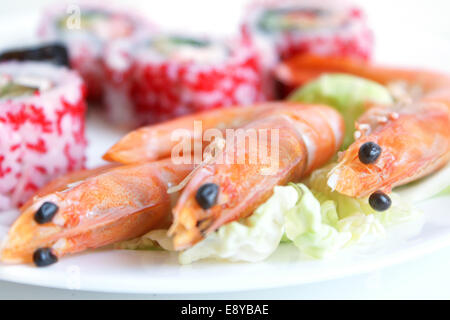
[[169, 103, 344, 250]]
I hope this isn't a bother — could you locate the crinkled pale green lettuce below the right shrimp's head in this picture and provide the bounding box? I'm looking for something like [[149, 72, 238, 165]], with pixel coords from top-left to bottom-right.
[[285, 164, 421, 258]]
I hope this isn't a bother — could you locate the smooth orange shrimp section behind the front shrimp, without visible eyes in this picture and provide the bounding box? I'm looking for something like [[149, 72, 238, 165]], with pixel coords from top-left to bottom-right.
[[103, 103, 284, 164]]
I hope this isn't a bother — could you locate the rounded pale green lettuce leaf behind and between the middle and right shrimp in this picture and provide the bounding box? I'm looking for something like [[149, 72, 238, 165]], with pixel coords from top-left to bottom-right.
[[289, 73, 393, 149]]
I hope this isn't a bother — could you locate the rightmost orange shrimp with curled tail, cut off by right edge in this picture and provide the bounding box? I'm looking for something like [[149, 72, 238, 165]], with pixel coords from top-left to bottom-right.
[[276, 56, 450, 197]]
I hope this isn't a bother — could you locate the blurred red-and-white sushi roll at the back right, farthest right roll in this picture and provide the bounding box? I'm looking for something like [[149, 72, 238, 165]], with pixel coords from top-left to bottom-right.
[[241, 0, 373, 98]]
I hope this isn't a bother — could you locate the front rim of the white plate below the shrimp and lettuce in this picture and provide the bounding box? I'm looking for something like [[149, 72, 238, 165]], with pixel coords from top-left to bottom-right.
[[0, 197, 450, 294]]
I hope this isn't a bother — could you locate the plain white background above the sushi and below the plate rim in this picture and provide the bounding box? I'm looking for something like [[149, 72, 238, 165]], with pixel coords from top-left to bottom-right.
[[0, 0, 450, 299]]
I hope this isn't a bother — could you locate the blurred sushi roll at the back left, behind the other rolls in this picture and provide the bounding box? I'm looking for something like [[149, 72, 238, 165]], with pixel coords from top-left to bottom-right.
[[39, 2, 153, 100]]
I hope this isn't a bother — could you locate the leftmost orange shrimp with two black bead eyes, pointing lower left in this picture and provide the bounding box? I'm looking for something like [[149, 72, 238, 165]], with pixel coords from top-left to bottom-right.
[[0, 160, 192, 265]]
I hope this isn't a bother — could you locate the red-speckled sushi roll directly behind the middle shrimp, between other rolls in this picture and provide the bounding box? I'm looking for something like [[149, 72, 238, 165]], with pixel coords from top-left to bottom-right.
[[105, 33, 264, 127]]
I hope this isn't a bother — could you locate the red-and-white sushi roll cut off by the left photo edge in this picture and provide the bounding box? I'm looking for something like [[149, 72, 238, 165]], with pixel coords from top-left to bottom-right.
[[0, 61, 86, 210]]
